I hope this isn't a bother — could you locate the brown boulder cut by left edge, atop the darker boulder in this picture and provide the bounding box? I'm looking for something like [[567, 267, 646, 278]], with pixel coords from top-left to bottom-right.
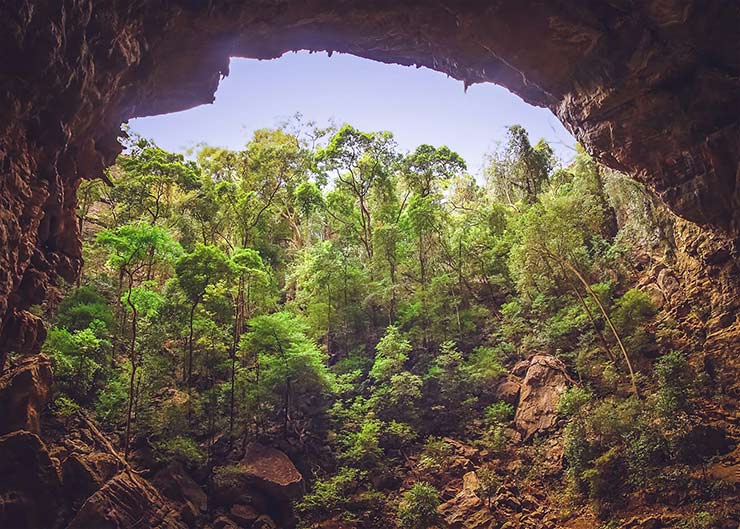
[[0, 354, 52, 435]]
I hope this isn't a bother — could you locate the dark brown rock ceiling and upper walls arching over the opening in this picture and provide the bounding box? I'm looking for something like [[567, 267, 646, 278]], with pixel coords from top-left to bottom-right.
[[0, 0, 740, 524]]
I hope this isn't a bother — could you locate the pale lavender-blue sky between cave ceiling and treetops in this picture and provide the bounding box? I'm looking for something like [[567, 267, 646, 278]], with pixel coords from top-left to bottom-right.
[[129, 52, 575, 175]]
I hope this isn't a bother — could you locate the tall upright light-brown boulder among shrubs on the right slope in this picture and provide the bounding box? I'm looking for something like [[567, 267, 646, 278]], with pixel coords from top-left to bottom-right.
[[514, 354, 572, 441]]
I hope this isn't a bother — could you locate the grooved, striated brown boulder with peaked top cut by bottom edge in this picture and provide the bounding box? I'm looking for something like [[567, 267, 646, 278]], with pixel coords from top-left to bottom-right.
[[67, 470, 187, 529]]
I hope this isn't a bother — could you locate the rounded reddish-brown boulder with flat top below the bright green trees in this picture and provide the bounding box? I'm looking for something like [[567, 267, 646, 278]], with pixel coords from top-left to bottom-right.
[[240, 443, 304, 501]]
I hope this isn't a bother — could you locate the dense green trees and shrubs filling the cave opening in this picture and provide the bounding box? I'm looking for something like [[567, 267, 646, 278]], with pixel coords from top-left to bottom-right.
[[36, 118, 724, 528]]
